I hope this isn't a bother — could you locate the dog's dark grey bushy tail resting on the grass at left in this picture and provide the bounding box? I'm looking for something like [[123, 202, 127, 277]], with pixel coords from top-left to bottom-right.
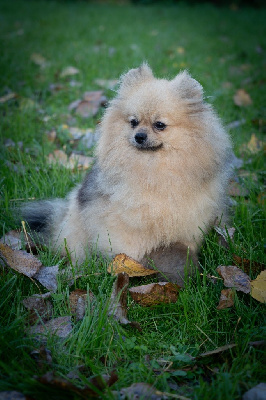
[[20, 199, 67, 244]]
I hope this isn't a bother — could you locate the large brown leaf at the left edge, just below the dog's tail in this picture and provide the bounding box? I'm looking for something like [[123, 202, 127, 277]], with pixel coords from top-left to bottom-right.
[[0, 243, 42, 278]]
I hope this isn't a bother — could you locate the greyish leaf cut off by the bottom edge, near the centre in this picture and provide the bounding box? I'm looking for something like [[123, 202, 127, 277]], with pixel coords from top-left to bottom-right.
[[113, 382, 167, 400]]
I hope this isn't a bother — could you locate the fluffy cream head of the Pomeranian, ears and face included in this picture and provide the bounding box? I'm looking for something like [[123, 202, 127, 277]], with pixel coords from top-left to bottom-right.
[[104, 64, 204, 151]]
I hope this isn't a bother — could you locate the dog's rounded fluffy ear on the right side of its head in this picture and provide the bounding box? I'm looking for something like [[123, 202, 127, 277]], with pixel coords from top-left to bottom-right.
[[172, 71, 203, 101]]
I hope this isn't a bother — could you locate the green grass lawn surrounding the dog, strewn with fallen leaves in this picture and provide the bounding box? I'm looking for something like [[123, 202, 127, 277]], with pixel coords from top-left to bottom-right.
[[0, 0, 266, 400]]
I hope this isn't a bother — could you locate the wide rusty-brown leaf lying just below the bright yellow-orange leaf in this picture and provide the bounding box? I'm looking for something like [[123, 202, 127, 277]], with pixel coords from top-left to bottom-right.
[[129, 282, 181, 306]]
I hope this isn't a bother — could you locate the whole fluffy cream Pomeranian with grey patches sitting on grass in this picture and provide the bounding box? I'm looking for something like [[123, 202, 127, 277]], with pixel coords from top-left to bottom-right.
[[24, 64, 231, 284]]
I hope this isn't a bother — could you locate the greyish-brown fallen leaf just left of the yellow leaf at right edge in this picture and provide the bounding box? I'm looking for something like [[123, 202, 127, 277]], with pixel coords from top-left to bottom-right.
[[216, 265, 250, 293]]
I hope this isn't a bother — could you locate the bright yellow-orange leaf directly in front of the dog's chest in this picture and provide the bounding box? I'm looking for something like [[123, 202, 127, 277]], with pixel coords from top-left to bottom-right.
[[107, 253, 158, 277]]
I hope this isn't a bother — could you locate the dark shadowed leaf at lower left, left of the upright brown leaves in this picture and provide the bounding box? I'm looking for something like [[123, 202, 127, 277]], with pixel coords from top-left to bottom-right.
[[22, 292, 53, 325]]
